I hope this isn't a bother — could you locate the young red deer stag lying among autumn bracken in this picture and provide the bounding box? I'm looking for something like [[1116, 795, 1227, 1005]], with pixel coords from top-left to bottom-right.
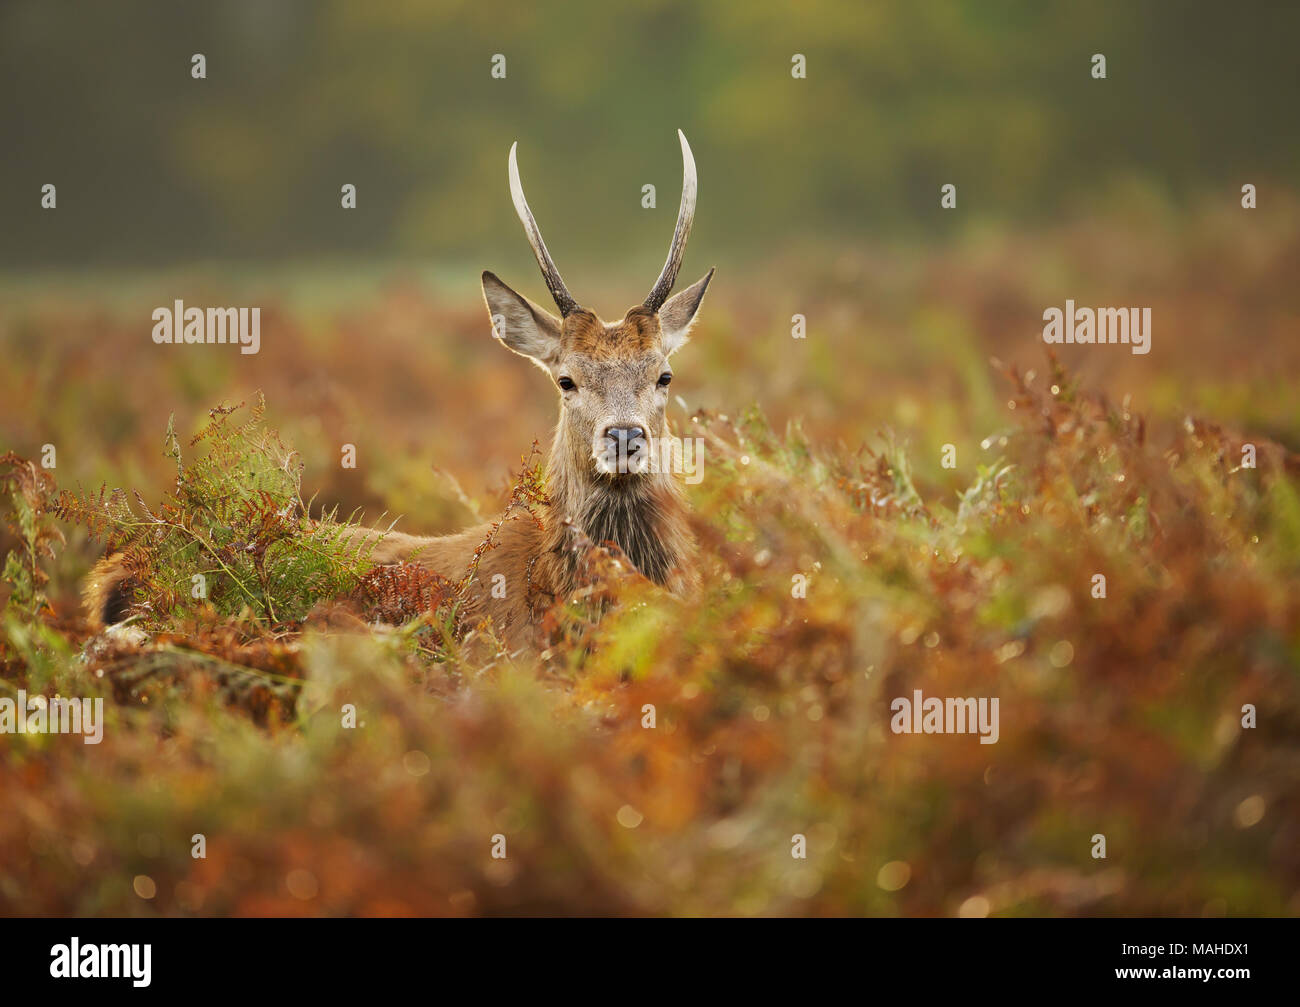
[[86, 130, 714, 641]]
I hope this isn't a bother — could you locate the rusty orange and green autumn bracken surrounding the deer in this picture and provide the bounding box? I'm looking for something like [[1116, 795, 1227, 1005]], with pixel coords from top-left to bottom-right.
[[0, 209, 1300, 916]]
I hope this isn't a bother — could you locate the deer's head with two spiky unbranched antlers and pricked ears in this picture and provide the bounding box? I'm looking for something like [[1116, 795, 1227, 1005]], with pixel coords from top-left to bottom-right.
[[482, 130, 714, 487]]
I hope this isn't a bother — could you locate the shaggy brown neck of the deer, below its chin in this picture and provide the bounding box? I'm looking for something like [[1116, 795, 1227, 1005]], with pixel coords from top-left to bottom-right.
[[546, 427, 688, 583]]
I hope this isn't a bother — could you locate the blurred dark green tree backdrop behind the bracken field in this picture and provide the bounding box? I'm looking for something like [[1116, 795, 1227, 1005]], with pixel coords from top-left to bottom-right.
[[0, 0, 1300, 277]]
